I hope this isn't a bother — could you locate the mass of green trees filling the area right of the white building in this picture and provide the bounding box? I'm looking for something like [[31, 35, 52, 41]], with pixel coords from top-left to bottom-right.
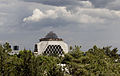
[[63, 46, 120, 76]]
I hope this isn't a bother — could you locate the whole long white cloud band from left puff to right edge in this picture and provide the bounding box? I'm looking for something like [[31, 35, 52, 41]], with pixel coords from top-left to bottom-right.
[[23, 7, 120, 24]]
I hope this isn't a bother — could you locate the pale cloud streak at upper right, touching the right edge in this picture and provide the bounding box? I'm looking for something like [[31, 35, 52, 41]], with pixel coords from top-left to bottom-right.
[[76, 7, 120, 18]]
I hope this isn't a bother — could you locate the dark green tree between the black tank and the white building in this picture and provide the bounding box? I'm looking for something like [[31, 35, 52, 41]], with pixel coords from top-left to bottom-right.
[[17, 49, 34, 76]]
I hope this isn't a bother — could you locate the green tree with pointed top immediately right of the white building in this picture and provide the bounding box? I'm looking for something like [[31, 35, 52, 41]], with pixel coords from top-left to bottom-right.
[[63, 46, 88, 76]]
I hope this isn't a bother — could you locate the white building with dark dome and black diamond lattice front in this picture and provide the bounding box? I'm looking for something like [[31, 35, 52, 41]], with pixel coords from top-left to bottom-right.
[[34, 31, 68, 56]]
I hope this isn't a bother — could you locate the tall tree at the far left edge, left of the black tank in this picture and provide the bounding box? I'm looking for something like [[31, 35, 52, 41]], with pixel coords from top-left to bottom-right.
[[0, 42, 12, 76]]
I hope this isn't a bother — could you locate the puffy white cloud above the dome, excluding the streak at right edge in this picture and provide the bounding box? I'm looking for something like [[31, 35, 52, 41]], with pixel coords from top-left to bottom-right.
[[23, 7, 104, 23]]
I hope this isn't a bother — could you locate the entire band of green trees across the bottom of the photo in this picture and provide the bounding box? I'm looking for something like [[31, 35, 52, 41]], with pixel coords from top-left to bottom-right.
[[0, 43, 120, 76]]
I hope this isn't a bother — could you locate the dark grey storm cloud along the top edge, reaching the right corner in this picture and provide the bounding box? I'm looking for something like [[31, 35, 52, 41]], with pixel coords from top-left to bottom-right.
[[24, 0, 120, 10]]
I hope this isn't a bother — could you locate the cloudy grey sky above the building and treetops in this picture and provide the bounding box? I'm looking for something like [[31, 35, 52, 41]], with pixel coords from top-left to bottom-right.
[[0, 0, 120, 51]]
